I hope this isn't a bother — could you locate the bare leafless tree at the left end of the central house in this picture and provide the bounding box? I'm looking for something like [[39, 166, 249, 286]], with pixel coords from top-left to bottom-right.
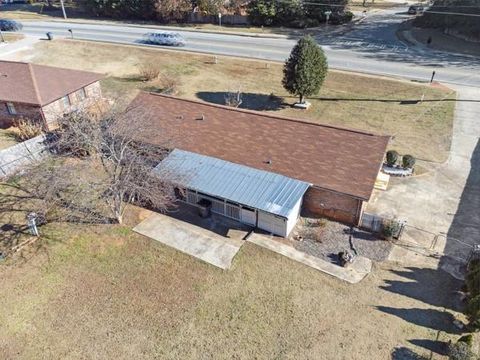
[[53, 110, 174, 223]]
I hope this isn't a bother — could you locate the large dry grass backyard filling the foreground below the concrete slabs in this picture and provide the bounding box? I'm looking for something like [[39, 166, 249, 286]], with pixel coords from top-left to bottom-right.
[[0, 205, 464, 360]]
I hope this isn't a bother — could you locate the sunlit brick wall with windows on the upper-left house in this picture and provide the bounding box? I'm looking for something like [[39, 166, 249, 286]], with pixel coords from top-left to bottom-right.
[[43, 81, 102, 130]]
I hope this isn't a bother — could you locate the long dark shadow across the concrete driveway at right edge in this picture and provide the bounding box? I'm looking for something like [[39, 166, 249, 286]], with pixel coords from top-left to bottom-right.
[[440, 141, 480, 274]]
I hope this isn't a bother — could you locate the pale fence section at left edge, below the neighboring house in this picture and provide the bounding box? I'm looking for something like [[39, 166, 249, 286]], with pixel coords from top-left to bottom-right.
[[0, 135, 48, 178]]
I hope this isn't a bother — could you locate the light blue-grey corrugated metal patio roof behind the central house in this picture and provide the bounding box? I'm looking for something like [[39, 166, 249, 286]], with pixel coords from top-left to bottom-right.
[[155, 149, 311, 218]]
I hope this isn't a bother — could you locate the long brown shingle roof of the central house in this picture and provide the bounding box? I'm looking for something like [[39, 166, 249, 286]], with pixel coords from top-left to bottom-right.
[[128, 93, 389, 200]]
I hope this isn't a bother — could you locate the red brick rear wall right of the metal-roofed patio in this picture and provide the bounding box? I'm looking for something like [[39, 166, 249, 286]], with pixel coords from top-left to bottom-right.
[[303, 187, 363, 225]]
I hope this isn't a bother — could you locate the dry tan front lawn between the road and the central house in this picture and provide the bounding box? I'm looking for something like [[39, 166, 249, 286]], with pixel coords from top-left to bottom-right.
[[9, 41, 455, 161]]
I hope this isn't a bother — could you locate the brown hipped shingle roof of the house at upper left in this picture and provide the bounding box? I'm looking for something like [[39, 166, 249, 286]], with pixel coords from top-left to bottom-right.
[[0, 61, 103, 106]]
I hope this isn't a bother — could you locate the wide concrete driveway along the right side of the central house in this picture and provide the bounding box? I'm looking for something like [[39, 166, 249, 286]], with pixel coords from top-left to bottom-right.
[[367, 83, 480, 277]]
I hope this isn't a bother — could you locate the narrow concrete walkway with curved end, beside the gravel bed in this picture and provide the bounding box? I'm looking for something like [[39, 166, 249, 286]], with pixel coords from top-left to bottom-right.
[[247, 233, 372, 284]]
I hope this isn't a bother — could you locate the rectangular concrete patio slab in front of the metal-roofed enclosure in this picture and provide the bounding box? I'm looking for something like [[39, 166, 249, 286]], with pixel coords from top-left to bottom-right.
[[133, 213, 246, 269]]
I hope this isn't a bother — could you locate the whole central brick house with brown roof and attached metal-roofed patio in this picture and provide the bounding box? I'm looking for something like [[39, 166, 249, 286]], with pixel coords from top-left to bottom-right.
[[125, 93, 389, 236]]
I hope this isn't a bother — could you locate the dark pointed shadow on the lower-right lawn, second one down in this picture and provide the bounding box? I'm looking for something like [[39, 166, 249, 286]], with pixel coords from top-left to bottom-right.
[[376, 306, 460, 334]]
